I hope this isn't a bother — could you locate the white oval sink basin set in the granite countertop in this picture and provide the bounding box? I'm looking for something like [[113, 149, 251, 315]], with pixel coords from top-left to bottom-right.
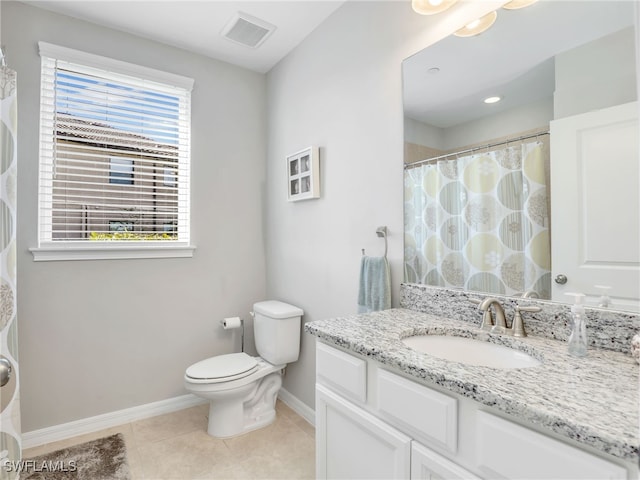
[[402, 335, 541, 368]]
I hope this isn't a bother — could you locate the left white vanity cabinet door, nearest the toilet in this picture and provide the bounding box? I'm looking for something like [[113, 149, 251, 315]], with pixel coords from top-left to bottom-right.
[[316, 384, 411, 480]]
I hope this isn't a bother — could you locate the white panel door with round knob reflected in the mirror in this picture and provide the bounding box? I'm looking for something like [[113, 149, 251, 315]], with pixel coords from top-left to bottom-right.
[[551, 102, 640, 310]]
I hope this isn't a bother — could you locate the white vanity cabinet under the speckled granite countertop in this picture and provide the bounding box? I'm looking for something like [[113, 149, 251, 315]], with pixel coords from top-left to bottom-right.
[[316, 342, 635, 480]]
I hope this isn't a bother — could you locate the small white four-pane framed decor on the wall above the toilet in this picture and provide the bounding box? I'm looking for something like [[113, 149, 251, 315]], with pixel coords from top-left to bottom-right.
[[287, 147, 320, 202]]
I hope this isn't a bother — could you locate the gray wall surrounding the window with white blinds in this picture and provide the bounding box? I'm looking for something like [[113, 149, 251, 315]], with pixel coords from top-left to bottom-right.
[[1, 2, 268, 432]]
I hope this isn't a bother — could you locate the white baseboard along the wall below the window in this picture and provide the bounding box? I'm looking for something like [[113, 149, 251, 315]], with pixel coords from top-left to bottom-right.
[[22, 393, 205, 448]]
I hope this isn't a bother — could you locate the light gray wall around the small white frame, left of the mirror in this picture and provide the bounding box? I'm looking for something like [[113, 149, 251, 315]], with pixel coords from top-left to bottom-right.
[[267, 2, 504, 406]]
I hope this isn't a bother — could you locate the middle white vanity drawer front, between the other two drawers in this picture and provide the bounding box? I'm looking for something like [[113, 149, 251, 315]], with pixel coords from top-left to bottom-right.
[[377, 369, 458, 453]]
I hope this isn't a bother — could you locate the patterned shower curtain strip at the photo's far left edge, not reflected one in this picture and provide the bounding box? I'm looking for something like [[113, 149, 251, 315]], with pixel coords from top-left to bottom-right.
[[0, 61, 21, 479]]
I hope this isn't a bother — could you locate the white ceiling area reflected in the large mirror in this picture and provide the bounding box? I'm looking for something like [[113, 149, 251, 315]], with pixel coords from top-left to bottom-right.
[[402, 0, 634, 128]]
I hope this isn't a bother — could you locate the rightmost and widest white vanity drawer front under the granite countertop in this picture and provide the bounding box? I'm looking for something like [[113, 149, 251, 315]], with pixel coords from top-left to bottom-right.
[[476, 411, 627, 480]]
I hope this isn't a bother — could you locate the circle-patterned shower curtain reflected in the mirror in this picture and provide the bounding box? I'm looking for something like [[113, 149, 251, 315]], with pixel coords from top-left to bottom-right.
[[404, 141, 551, 298]]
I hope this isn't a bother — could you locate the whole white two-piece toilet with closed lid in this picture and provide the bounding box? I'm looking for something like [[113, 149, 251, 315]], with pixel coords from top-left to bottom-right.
[[184, 300, 304, 438]]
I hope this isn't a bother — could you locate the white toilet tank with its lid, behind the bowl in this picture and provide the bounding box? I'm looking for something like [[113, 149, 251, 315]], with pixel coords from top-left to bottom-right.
[[253, 300, 304, 365]]
